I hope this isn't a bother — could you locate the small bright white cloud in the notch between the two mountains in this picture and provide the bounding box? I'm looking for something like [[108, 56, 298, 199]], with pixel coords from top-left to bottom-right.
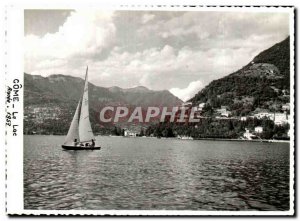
[[170, 80, 204, 101]]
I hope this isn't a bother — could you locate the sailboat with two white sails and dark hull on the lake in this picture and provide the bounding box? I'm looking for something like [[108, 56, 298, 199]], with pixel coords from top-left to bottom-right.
[[62, 67, 101, 150]]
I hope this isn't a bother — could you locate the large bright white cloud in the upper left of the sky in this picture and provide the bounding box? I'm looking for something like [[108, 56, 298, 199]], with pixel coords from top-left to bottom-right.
[[25, 10, 116, 74]]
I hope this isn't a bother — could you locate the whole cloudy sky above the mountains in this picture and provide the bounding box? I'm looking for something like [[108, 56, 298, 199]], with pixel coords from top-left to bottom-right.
[[24, 10, 289, 101]]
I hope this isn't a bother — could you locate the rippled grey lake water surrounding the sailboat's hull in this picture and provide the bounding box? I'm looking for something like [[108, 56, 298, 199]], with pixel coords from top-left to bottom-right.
[[24, 136, 289, 210]]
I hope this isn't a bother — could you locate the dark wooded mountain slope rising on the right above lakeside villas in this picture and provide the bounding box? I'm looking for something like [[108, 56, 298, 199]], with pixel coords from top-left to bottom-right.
[[190, 37, 290, 116]]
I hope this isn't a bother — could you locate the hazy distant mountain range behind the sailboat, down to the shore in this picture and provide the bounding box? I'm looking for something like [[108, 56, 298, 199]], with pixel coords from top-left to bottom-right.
[[24, 73, 182, 134]]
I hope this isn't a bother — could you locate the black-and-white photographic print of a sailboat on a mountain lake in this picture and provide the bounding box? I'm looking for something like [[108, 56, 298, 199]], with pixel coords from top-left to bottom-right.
[[6, 4, 295, 216]]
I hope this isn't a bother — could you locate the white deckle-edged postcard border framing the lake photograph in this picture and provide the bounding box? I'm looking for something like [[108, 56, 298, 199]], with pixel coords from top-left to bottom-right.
[[4, 2, 295, 216]]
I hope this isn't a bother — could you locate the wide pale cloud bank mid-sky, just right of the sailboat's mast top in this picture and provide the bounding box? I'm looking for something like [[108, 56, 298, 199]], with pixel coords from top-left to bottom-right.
[[87, 45, 225, 90]]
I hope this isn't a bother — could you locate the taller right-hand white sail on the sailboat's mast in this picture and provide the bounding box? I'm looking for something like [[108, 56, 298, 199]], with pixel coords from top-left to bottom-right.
[[79, 68, 95, 142]]
